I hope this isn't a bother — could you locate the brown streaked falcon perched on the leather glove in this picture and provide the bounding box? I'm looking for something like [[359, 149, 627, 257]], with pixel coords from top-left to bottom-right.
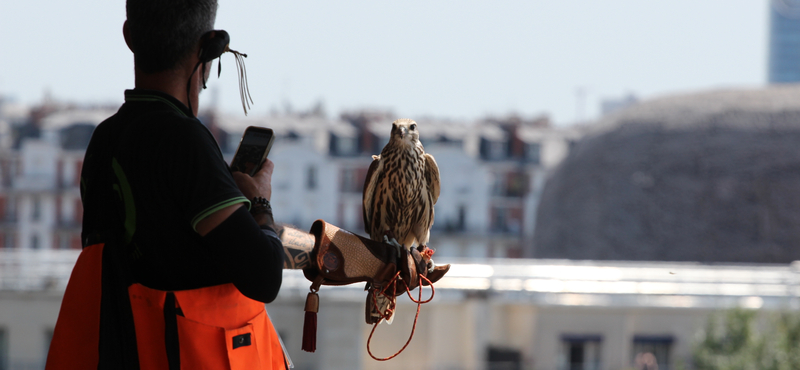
[[363, 119, 439, 254]]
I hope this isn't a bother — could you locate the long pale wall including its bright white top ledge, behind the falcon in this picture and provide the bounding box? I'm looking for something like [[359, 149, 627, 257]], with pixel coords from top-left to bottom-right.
[[0, 260, 798, 370]]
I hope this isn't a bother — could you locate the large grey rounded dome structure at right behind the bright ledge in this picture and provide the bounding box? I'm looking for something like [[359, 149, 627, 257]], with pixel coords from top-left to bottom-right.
[[527, 85, 800, 263]]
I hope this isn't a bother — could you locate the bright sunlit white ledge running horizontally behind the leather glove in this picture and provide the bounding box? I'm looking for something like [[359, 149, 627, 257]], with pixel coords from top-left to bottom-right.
[[0, 249, 800, 309]]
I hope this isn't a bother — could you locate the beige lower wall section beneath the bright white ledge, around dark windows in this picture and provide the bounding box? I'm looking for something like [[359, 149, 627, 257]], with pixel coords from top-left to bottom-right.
[[0, 287, 780, 370]]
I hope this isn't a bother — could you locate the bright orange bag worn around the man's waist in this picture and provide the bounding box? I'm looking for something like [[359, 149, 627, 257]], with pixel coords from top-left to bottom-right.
[[45, 244, 288, 370]]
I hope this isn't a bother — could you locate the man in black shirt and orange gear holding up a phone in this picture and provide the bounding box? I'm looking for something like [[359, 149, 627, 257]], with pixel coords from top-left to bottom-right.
[[47, 0, 312, 369]]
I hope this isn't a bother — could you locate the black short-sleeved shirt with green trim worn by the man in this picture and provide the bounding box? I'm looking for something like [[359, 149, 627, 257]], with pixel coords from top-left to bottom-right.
[[81, 89, 264, 290]]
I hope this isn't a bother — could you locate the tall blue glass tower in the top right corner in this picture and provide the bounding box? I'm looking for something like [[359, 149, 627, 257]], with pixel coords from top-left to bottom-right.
[[769, 0, 800, 83]]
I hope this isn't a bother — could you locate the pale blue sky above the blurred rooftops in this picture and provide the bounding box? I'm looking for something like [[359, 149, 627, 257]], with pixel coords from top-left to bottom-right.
[[0, 0, 769, 125]]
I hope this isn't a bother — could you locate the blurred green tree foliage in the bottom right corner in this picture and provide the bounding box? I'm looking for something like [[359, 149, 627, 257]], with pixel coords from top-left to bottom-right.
[[692, 309, 800, 370]]
